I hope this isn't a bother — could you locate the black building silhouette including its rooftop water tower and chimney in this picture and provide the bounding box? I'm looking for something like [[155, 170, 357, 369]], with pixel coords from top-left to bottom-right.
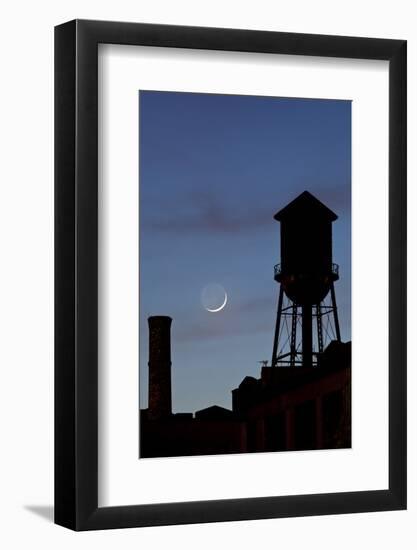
[[140, 192, 351, 458]]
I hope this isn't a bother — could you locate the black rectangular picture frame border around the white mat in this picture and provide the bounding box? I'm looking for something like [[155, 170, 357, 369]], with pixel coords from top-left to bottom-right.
[[55, 20, 407, 531]]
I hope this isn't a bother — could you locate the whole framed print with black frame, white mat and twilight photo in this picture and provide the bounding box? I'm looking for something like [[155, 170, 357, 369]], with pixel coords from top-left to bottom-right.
[[55, 21, 406, 530]]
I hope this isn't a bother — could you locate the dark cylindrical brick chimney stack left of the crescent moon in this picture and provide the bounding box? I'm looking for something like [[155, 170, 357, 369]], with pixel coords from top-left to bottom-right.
[[148, 315, 172, 420]]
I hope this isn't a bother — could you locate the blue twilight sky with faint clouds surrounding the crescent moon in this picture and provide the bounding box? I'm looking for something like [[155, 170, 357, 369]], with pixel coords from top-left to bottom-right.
[[139, 91, 351, 412]]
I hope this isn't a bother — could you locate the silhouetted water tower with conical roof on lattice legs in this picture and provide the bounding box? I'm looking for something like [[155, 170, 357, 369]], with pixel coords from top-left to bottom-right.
[[271, 191, 340, 367]]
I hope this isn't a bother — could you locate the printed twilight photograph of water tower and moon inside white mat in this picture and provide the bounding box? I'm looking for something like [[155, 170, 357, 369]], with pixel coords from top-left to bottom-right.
[[138, 90, 352, 459]]
